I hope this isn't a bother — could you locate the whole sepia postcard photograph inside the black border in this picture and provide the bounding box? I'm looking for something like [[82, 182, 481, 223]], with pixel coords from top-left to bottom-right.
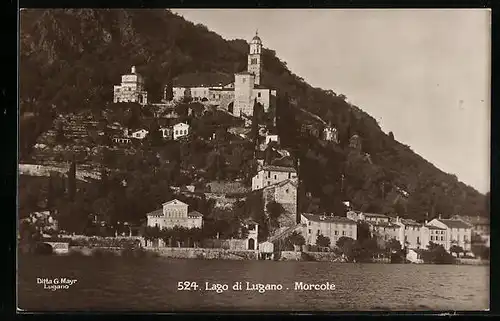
[[17, 8, 491, 313]]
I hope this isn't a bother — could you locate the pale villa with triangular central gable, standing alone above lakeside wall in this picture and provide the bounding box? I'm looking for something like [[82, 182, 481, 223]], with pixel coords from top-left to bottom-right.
[[147, 199, 203, 230]]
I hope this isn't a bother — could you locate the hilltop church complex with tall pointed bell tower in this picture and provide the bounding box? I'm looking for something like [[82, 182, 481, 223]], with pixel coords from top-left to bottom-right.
[[165, 33, 276, 117]]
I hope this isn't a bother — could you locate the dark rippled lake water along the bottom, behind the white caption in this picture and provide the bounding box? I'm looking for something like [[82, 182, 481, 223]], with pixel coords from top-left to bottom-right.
[[18, 256, 489, 312]]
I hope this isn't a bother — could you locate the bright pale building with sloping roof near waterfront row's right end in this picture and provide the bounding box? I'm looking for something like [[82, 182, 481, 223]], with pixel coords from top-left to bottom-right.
[[428, 216, 473, 251]]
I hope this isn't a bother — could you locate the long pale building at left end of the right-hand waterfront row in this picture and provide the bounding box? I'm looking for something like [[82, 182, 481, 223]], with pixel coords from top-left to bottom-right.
[[301, 213, 358, 247]]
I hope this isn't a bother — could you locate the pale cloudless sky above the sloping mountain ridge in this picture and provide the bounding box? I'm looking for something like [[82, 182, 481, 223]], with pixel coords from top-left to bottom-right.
[[172, 9, 490, 193]]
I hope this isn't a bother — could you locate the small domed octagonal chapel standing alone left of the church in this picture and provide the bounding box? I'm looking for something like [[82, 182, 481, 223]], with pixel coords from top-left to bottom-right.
[[113, 66, 148, 106]]
